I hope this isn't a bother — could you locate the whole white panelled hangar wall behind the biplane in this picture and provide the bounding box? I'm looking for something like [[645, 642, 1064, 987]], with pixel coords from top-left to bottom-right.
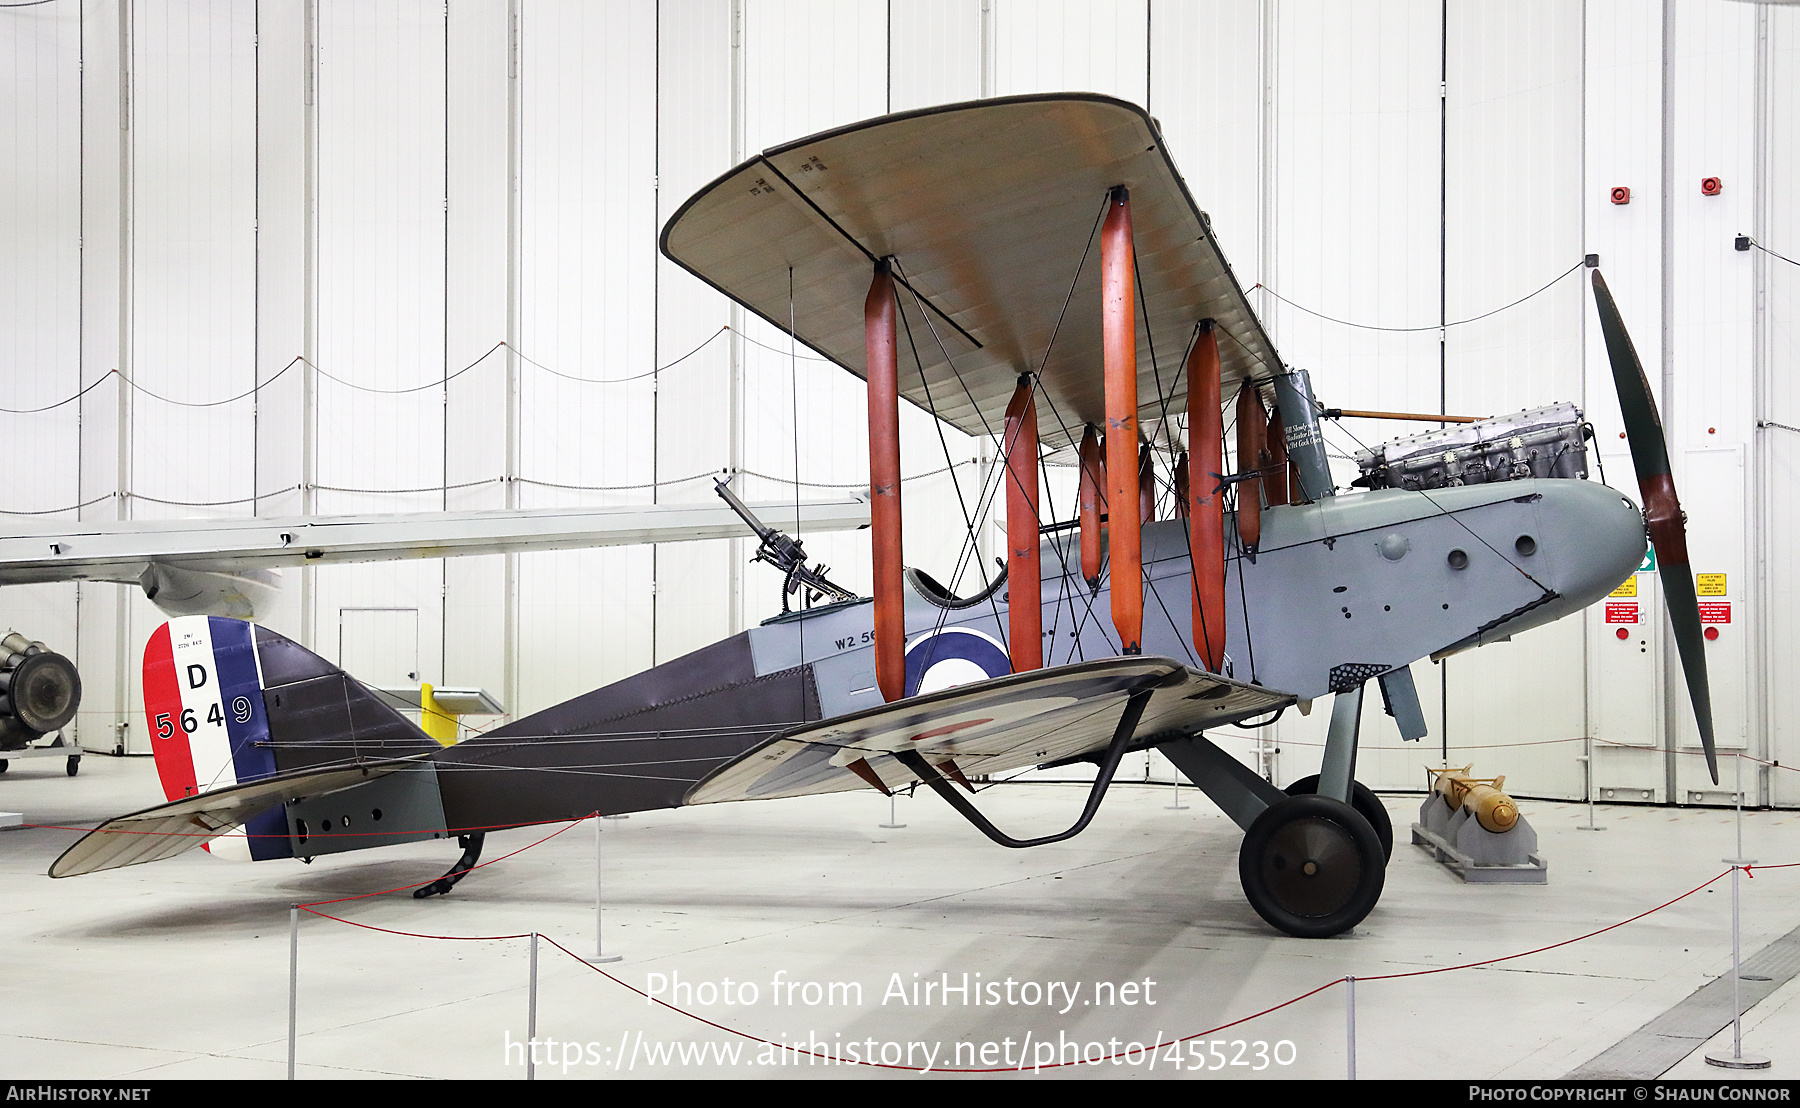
[[0, 0, 1800, 804]]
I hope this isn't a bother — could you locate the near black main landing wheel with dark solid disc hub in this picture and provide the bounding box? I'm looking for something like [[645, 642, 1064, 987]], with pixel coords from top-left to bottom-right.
[[1238, 795, 1388, 939]]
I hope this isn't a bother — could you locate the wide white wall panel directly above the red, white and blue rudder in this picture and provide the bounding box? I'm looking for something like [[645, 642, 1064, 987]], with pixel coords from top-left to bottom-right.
[[131, 0, 257, 518]]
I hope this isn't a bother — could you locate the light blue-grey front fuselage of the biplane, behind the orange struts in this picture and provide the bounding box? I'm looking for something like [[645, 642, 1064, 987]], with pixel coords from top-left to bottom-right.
[[749, 480, 1645, 716]]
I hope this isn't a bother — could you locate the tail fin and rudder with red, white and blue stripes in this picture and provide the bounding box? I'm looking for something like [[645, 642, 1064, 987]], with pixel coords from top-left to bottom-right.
[[144, 615, 437, 860]]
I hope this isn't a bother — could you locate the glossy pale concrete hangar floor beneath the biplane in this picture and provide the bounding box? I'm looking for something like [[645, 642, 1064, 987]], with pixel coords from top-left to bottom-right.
[[0, 757, 1800, 1079]]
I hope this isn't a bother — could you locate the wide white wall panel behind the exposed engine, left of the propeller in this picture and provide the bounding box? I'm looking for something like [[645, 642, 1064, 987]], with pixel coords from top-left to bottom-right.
[[1432, 0, 1588, 797]]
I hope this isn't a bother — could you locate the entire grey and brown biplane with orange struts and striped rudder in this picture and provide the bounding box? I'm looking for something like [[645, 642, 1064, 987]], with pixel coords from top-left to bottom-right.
[[50, 94, 1714, 937]]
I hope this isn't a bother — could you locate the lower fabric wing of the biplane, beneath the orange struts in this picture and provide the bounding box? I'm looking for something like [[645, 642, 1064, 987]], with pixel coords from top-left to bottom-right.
[[686, 657, 1294, 804]]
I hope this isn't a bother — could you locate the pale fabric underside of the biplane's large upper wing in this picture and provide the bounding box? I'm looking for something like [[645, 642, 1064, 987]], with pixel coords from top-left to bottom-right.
[[662, 94, 1282, 448]]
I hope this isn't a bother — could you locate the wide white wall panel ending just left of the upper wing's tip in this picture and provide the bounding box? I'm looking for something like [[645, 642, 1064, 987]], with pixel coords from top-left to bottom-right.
[[509, 0, 657, 710]]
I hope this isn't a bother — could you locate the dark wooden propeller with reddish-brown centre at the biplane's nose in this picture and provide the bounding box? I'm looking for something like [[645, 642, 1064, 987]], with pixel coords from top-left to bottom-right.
[[1593, 270, 1719, 784]]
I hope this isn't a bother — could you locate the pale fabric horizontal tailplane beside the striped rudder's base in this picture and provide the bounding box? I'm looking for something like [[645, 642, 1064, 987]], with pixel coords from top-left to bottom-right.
[[50, 754, 430, 878]]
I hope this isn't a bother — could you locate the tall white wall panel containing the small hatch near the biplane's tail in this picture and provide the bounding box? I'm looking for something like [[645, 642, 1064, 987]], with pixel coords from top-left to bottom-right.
[[311, 0, 446, 680]]
